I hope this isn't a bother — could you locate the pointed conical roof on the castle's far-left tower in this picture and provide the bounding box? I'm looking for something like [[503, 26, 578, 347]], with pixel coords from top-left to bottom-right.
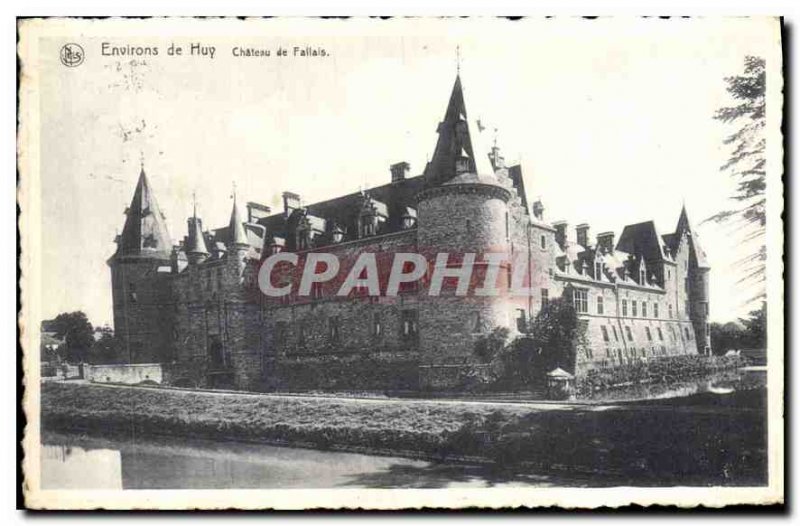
[[115, 163, 172, 260]]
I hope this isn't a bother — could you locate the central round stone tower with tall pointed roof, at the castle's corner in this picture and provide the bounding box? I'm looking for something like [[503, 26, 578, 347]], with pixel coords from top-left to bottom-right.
[[417, 73, 511, 363]]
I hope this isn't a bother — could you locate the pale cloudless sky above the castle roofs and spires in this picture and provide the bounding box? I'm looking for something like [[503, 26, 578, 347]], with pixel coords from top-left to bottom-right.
[[32, 18, 780, 325]]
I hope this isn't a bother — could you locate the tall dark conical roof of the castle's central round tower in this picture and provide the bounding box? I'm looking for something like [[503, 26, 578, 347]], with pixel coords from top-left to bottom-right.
[[425, 75, 494, 185]]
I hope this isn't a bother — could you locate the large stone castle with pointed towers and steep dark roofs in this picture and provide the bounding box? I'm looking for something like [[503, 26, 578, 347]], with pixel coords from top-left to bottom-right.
[[108, 76, 710, 390]]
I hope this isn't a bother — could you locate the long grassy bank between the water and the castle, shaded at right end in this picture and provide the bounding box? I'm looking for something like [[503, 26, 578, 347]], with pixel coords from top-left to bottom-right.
[[42, 383, 765, 485]]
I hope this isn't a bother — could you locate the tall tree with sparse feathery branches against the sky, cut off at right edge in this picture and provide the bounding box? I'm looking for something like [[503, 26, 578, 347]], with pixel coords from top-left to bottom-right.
[[706, 56, 767, 303]]
